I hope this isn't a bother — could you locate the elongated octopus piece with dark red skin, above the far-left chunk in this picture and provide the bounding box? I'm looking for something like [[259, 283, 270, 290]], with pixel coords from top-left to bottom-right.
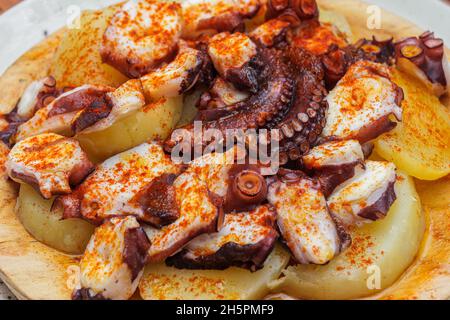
[[16, 85, 114, 141]]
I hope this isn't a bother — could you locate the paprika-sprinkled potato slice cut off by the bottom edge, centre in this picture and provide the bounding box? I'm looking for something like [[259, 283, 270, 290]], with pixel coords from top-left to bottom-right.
[[139, 246, 290, 300]]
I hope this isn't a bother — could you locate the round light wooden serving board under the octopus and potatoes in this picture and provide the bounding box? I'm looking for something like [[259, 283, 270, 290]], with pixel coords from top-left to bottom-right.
[[0, 0, 450, 299]]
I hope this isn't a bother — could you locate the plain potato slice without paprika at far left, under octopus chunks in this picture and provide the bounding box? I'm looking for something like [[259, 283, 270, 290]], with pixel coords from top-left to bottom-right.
[[16, 184, 94, 254]]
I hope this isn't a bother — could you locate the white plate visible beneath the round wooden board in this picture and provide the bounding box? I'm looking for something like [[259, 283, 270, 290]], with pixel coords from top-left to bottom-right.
[[0, 0, 450, 300]]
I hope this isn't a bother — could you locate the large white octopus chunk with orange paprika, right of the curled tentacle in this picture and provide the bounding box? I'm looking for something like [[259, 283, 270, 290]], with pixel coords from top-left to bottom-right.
[[322, 61, 403, 143]]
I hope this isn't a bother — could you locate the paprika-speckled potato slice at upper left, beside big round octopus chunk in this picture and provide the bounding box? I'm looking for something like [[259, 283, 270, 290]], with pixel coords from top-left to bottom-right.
[[50, 6, 127, 87]]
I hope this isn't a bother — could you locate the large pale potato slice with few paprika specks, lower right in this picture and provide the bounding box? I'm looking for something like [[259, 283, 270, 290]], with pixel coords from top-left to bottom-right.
[[276, 173, 425, 299]]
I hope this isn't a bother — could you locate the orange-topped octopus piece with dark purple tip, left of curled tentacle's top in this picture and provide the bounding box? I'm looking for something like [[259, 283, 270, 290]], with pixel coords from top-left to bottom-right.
[[208, 32, 258, 92]]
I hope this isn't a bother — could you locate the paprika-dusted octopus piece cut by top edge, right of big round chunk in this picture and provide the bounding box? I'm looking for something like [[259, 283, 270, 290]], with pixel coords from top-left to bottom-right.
[[181, 0, 262, 39]]
